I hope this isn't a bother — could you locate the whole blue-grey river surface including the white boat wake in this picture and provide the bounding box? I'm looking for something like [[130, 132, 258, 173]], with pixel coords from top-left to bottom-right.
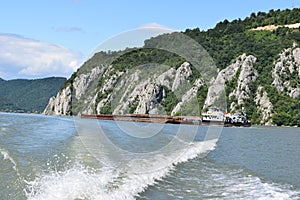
[[0, 113, 300, 200]]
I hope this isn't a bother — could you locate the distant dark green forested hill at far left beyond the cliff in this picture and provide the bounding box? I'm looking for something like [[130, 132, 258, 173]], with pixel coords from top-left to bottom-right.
[[0, 77, 66, 113]]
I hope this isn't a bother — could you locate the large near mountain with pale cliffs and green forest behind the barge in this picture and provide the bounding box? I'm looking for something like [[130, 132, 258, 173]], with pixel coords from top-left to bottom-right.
[[44, 8, 300, 126]]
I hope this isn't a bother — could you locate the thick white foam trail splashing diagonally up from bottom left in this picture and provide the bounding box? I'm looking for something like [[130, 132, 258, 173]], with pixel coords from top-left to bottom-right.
[[25, 140, 217, 200]]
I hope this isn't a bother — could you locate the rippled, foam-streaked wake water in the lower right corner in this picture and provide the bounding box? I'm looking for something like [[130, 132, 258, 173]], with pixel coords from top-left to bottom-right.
[[152, 159, 300, 200]]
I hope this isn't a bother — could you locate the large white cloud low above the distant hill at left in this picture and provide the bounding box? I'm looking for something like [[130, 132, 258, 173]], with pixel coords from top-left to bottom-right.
[[0, 34, 82, 79]]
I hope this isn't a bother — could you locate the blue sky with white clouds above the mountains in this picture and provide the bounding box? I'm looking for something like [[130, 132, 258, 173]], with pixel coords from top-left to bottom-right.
[[0, 0, 300, 79]]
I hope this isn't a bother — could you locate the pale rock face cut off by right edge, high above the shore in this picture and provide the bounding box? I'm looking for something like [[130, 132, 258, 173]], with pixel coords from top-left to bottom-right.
[[272, 43, 300, 98]]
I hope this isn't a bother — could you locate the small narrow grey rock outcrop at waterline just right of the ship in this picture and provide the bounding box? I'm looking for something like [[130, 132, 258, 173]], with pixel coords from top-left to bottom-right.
[[254, 86, 273, 125]]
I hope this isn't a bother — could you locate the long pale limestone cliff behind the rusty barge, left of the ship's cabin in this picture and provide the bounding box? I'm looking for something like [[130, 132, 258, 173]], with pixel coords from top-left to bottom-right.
[[44, 62, 204, 115]]
